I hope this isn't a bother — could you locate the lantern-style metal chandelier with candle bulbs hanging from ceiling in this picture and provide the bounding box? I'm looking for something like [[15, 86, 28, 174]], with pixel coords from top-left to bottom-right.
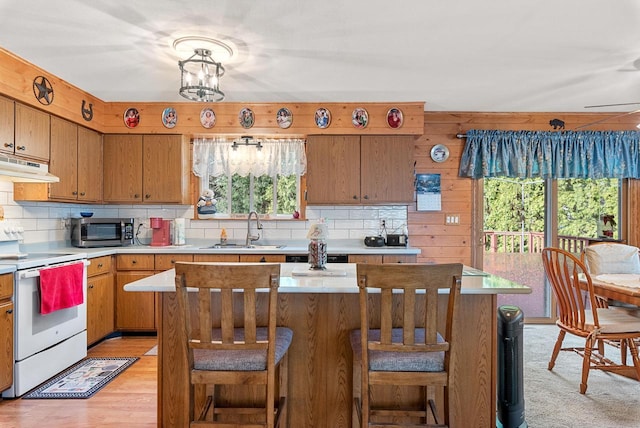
[[178, 48, 224, 102]]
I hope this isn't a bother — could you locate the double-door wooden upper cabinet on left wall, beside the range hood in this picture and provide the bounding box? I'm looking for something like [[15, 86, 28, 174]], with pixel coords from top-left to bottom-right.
[[14, 116, 102, 202]]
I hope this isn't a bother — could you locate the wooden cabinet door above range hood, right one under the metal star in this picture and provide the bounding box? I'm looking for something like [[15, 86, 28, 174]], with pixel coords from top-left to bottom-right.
[[12, 103, 51, 161]]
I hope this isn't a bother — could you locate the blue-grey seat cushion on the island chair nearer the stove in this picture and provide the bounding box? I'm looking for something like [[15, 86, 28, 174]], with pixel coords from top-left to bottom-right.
[[193, 327, 293, 371]]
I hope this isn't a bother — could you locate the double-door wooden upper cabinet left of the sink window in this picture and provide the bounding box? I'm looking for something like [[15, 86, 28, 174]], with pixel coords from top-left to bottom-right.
[[103, 134, 190, 204]]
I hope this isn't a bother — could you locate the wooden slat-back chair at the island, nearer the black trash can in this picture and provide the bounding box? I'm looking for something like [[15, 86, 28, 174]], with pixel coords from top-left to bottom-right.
[[351, 263, 462, 428]]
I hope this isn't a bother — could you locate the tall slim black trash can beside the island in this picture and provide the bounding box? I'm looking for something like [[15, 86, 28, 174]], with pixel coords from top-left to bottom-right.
[[496, 305, 527, 428]]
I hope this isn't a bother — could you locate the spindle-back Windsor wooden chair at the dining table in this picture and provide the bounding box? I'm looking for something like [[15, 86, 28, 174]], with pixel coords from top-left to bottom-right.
[[542, 247, 640, 394]]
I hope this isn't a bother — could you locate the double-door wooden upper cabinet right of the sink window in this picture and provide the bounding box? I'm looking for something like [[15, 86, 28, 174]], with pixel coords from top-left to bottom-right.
[[306, 135, 414, 205]]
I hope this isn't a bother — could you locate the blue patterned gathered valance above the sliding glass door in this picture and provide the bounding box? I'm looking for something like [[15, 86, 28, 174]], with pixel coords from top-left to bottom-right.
[[459, 130, 640, 178]]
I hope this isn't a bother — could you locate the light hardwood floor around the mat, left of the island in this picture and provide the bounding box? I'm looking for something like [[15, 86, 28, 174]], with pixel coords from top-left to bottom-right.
[[0, 336, 158, 428]]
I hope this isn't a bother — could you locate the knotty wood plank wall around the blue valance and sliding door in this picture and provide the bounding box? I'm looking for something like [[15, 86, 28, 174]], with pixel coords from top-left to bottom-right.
[[418, 112, 640, 267]]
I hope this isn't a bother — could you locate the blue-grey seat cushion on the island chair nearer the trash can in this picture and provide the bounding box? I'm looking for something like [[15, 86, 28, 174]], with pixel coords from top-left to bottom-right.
[[351, 328, 444, 372]]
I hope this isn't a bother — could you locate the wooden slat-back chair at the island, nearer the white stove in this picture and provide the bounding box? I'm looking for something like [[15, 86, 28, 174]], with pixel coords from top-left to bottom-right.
[[175, 262, 293, 428]]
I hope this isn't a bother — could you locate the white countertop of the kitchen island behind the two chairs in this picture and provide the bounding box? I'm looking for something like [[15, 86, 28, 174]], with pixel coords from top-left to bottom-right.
[[124, 263, 531, 294]]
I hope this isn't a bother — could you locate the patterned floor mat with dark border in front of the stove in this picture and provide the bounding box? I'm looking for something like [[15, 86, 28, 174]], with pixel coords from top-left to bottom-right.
[[22, 357, 139, 398]]
